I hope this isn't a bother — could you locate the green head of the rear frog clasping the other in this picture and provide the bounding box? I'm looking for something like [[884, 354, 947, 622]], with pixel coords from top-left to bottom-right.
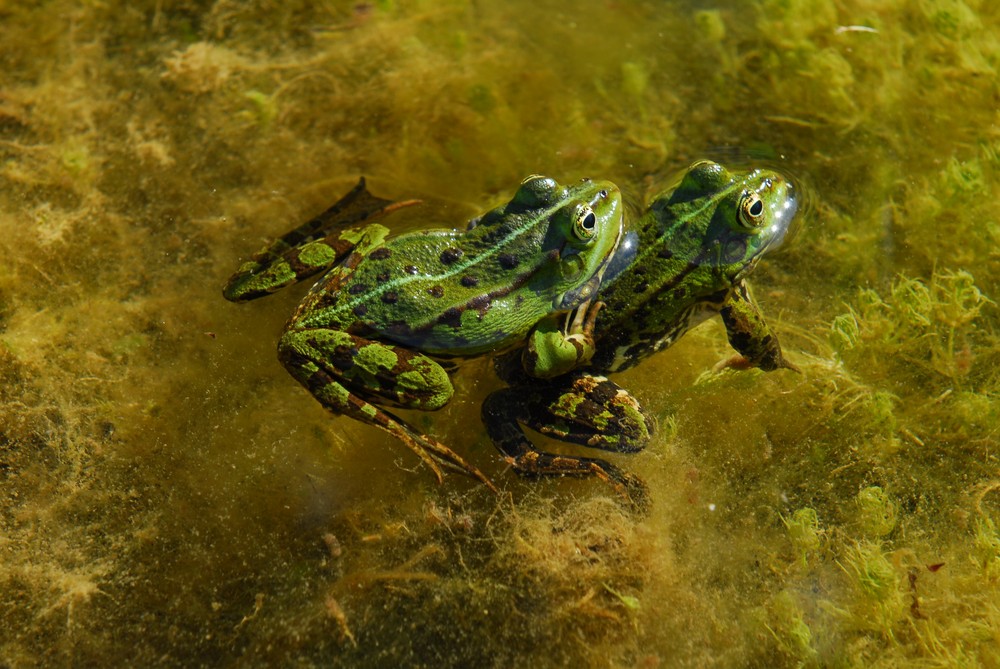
[[508, 175, 624, 310]]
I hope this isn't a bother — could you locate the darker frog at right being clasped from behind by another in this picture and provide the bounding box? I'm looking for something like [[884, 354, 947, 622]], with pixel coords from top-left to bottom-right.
[[482, 161, 798, 506]]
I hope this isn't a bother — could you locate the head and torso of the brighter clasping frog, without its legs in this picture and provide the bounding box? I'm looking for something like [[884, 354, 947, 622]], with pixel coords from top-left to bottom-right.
[[288, 175, 622, 356]]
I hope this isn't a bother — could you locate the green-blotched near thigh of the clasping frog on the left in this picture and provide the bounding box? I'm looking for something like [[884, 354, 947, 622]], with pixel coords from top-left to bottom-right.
[[278, 329, 454, 411]]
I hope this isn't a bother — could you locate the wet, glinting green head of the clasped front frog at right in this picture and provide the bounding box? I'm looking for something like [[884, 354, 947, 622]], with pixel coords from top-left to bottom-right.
[[653, 160, 799, 281]]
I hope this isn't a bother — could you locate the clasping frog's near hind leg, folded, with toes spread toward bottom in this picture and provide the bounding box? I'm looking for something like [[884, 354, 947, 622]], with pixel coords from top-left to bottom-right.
[[278, 328, 497, 492]]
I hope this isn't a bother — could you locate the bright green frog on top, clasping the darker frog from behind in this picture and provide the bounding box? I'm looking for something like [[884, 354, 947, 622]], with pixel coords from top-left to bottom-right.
[[223, 175, 623, 490]]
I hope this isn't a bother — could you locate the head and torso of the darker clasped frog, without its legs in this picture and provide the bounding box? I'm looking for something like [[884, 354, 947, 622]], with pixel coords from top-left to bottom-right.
[[593, 161, 797, 371]]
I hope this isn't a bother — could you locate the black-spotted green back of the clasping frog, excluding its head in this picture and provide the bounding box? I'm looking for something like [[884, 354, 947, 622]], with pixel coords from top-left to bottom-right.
[[299, 217, 552, 355]]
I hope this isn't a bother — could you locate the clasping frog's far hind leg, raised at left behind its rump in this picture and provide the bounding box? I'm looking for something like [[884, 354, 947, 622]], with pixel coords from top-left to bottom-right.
[[222, 177, 419, 302]]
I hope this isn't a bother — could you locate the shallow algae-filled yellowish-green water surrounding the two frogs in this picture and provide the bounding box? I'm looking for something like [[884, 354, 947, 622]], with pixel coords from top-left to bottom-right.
[[0, 0, 1000, 667]]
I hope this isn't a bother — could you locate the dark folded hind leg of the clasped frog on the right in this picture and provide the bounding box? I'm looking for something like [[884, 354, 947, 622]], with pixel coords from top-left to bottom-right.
[[482, 372, 655, 510]]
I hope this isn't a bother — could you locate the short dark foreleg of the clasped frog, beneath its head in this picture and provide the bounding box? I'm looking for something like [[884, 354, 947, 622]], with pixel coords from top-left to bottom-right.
[[719, 281, 799, 372]]
